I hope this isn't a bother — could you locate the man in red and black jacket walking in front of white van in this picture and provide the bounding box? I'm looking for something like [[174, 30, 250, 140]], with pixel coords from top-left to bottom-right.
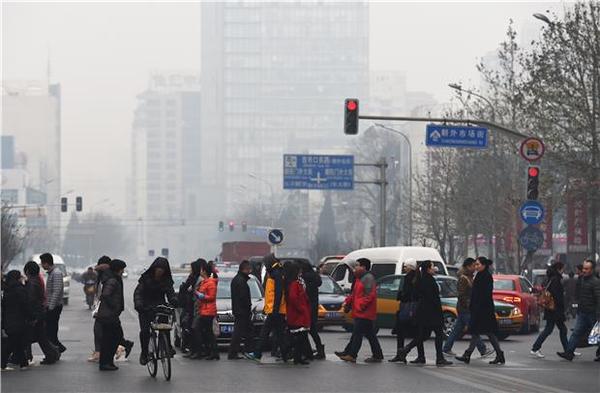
[[335, 258, 383, 363]]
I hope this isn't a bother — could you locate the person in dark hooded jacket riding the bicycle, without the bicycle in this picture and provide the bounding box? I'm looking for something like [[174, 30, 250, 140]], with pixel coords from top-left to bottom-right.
[[133, 257, 177, 366]]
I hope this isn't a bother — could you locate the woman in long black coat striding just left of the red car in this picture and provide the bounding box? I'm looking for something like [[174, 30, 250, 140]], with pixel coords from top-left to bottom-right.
[[456, 257, 505, 364]]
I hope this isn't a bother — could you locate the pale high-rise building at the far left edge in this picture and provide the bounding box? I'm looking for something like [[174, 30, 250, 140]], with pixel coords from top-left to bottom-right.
[[2, 81, 61, 247]]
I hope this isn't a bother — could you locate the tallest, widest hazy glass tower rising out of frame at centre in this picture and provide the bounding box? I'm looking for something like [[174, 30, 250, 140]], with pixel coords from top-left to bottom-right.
[[202, 1, 369, 234]]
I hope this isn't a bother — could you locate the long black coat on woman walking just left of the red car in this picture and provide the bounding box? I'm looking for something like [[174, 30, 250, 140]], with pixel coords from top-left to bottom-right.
[[469, 269, 498, 334]]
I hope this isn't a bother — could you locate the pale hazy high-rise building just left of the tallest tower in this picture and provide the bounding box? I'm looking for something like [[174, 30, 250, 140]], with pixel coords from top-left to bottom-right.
[[128, 73, 207, 260]]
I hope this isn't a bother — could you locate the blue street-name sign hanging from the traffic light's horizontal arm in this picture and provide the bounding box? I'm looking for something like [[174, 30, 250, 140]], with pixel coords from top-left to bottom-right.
[[425, 124, 488, 149]]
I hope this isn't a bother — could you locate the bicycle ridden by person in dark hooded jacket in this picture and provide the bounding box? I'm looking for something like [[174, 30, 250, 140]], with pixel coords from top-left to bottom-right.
[[147, 305, 175, 381]]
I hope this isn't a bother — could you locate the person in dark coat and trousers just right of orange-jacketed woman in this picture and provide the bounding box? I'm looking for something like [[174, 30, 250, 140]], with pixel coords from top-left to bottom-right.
[[227, 261, 253, 360]]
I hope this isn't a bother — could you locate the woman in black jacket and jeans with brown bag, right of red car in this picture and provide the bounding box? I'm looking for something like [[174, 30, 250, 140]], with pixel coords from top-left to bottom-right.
[[530, 262, 568, 358]]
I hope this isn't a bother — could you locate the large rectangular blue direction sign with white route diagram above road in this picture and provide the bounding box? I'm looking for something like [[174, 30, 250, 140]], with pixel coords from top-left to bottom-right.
[[283, 154, 354, 190]]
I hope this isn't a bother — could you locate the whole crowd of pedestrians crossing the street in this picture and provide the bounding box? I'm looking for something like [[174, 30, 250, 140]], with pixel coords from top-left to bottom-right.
[[2, 253, 600, 371]]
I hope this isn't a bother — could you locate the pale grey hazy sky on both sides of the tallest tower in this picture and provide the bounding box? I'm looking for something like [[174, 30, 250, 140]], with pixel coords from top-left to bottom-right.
[[2, 2, 562, 214]]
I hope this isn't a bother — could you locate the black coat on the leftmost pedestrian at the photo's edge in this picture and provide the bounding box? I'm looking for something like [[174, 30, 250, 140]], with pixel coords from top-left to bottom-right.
[[2, 280, 31, 335]]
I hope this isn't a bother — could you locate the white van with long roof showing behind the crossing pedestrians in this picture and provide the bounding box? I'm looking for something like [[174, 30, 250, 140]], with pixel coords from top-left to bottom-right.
[[331, 247, 448, 292]]
